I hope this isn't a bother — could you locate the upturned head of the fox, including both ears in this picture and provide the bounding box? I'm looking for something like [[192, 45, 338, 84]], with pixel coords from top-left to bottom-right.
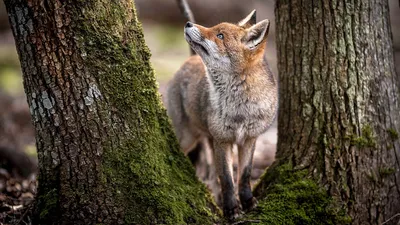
[[184, 10, 269, 71]]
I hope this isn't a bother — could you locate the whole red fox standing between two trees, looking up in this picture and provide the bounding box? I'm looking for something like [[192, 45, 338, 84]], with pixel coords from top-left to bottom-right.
[[166, 10, 278, 220]]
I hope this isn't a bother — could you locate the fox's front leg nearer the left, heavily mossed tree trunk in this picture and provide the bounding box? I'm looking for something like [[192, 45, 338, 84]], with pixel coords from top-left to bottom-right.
[[213, 141, 240, 220]]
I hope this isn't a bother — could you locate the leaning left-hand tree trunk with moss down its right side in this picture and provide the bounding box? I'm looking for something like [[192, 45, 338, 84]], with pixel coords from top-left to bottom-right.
[[5, 0, 216, 224]]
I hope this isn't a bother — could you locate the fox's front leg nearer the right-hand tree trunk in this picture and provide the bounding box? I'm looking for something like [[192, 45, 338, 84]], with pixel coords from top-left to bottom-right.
[[238, 138, 257, 211]]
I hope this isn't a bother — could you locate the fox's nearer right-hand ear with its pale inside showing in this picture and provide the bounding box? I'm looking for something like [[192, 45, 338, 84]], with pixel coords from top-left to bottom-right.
[[243, 20, 269, 49]]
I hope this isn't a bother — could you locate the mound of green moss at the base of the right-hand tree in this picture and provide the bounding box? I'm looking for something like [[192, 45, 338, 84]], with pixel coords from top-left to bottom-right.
[[243, 164, 351, 225]]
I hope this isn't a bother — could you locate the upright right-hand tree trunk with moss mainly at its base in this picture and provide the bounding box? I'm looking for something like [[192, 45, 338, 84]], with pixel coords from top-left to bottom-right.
[[247, 0, 400, 224]]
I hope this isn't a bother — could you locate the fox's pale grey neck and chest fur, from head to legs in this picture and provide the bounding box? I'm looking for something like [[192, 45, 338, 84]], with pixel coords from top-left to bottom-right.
[[205, 58, 277, 145]]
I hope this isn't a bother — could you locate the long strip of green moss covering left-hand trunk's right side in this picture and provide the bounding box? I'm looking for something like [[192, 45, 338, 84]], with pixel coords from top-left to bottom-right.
[[71, 1, 220, 225]]
